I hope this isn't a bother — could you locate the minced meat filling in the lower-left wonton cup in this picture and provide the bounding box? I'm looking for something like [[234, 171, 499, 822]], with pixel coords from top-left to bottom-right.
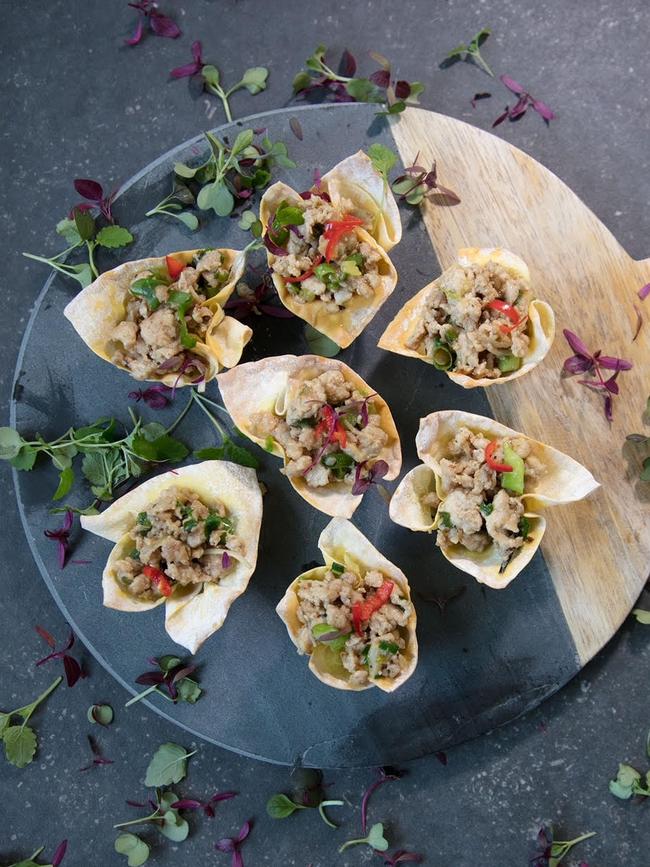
[[115, 488, 241, 600]]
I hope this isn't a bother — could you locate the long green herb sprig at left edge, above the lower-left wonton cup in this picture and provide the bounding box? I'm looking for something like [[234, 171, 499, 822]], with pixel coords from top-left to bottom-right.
[[0, 408, 192, 508]]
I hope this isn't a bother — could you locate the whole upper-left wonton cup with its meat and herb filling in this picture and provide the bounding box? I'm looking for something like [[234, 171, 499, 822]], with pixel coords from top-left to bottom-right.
[[63, 249, 253, 388]]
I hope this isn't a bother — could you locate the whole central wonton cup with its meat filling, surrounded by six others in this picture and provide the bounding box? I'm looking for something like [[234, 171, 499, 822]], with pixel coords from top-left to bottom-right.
[[217, 355, 402, 518]]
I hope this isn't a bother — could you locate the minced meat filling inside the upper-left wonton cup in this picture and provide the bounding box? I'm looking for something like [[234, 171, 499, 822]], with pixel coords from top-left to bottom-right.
[[108, 250, 230, 379]]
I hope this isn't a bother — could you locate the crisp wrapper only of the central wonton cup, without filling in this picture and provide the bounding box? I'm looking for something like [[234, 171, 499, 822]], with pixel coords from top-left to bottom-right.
[[217, 355, 402, 518]]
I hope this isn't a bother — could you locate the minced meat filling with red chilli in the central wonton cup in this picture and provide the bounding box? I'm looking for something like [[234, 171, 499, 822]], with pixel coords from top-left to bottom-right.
[[251, 370, 388, 488]]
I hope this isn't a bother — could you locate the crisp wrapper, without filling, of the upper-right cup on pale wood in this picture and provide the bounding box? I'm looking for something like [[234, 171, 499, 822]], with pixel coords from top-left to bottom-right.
[[377, 247, 555, 388]]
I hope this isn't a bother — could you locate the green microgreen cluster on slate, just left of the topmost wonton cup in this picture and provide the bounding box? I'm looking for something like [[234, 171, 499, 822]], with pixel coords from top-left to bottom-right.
[[146, 129, 296, 228]]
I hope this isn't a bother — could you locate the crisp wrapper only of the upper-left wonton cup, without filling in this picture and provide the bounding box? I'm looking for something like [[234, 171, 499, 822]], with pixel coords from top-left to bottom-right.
[[63, 249, 253, 390]]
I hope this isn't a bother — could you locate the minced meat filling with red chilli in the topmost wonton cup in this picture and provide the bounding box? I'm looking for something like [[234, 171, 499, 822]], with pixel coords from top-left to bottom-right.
[[272, 195, 382, 313]]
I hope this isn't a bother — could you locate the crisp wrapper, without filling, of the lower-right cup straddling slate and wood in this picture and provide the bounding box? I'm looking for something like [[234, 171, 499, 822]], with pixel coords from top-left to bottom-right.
[[390, 410, 600, 590]]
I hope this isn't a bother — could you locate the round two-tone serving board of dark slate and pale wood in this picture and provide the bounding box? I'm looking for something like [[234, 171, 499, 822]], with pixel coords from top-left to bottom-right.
[[12, 105, 650, 767]]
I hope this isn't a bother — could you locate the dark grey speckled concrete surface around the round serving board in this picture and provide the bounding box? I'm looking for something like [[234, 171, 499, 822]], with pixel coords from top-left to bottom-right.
[[0, 0, 650, 867]]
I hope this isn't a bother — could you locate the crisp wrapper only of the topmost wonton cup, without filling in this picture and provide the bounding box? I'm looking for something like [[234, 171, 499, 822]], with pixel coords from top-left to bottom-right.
[[260, 166, 401, 348]]
